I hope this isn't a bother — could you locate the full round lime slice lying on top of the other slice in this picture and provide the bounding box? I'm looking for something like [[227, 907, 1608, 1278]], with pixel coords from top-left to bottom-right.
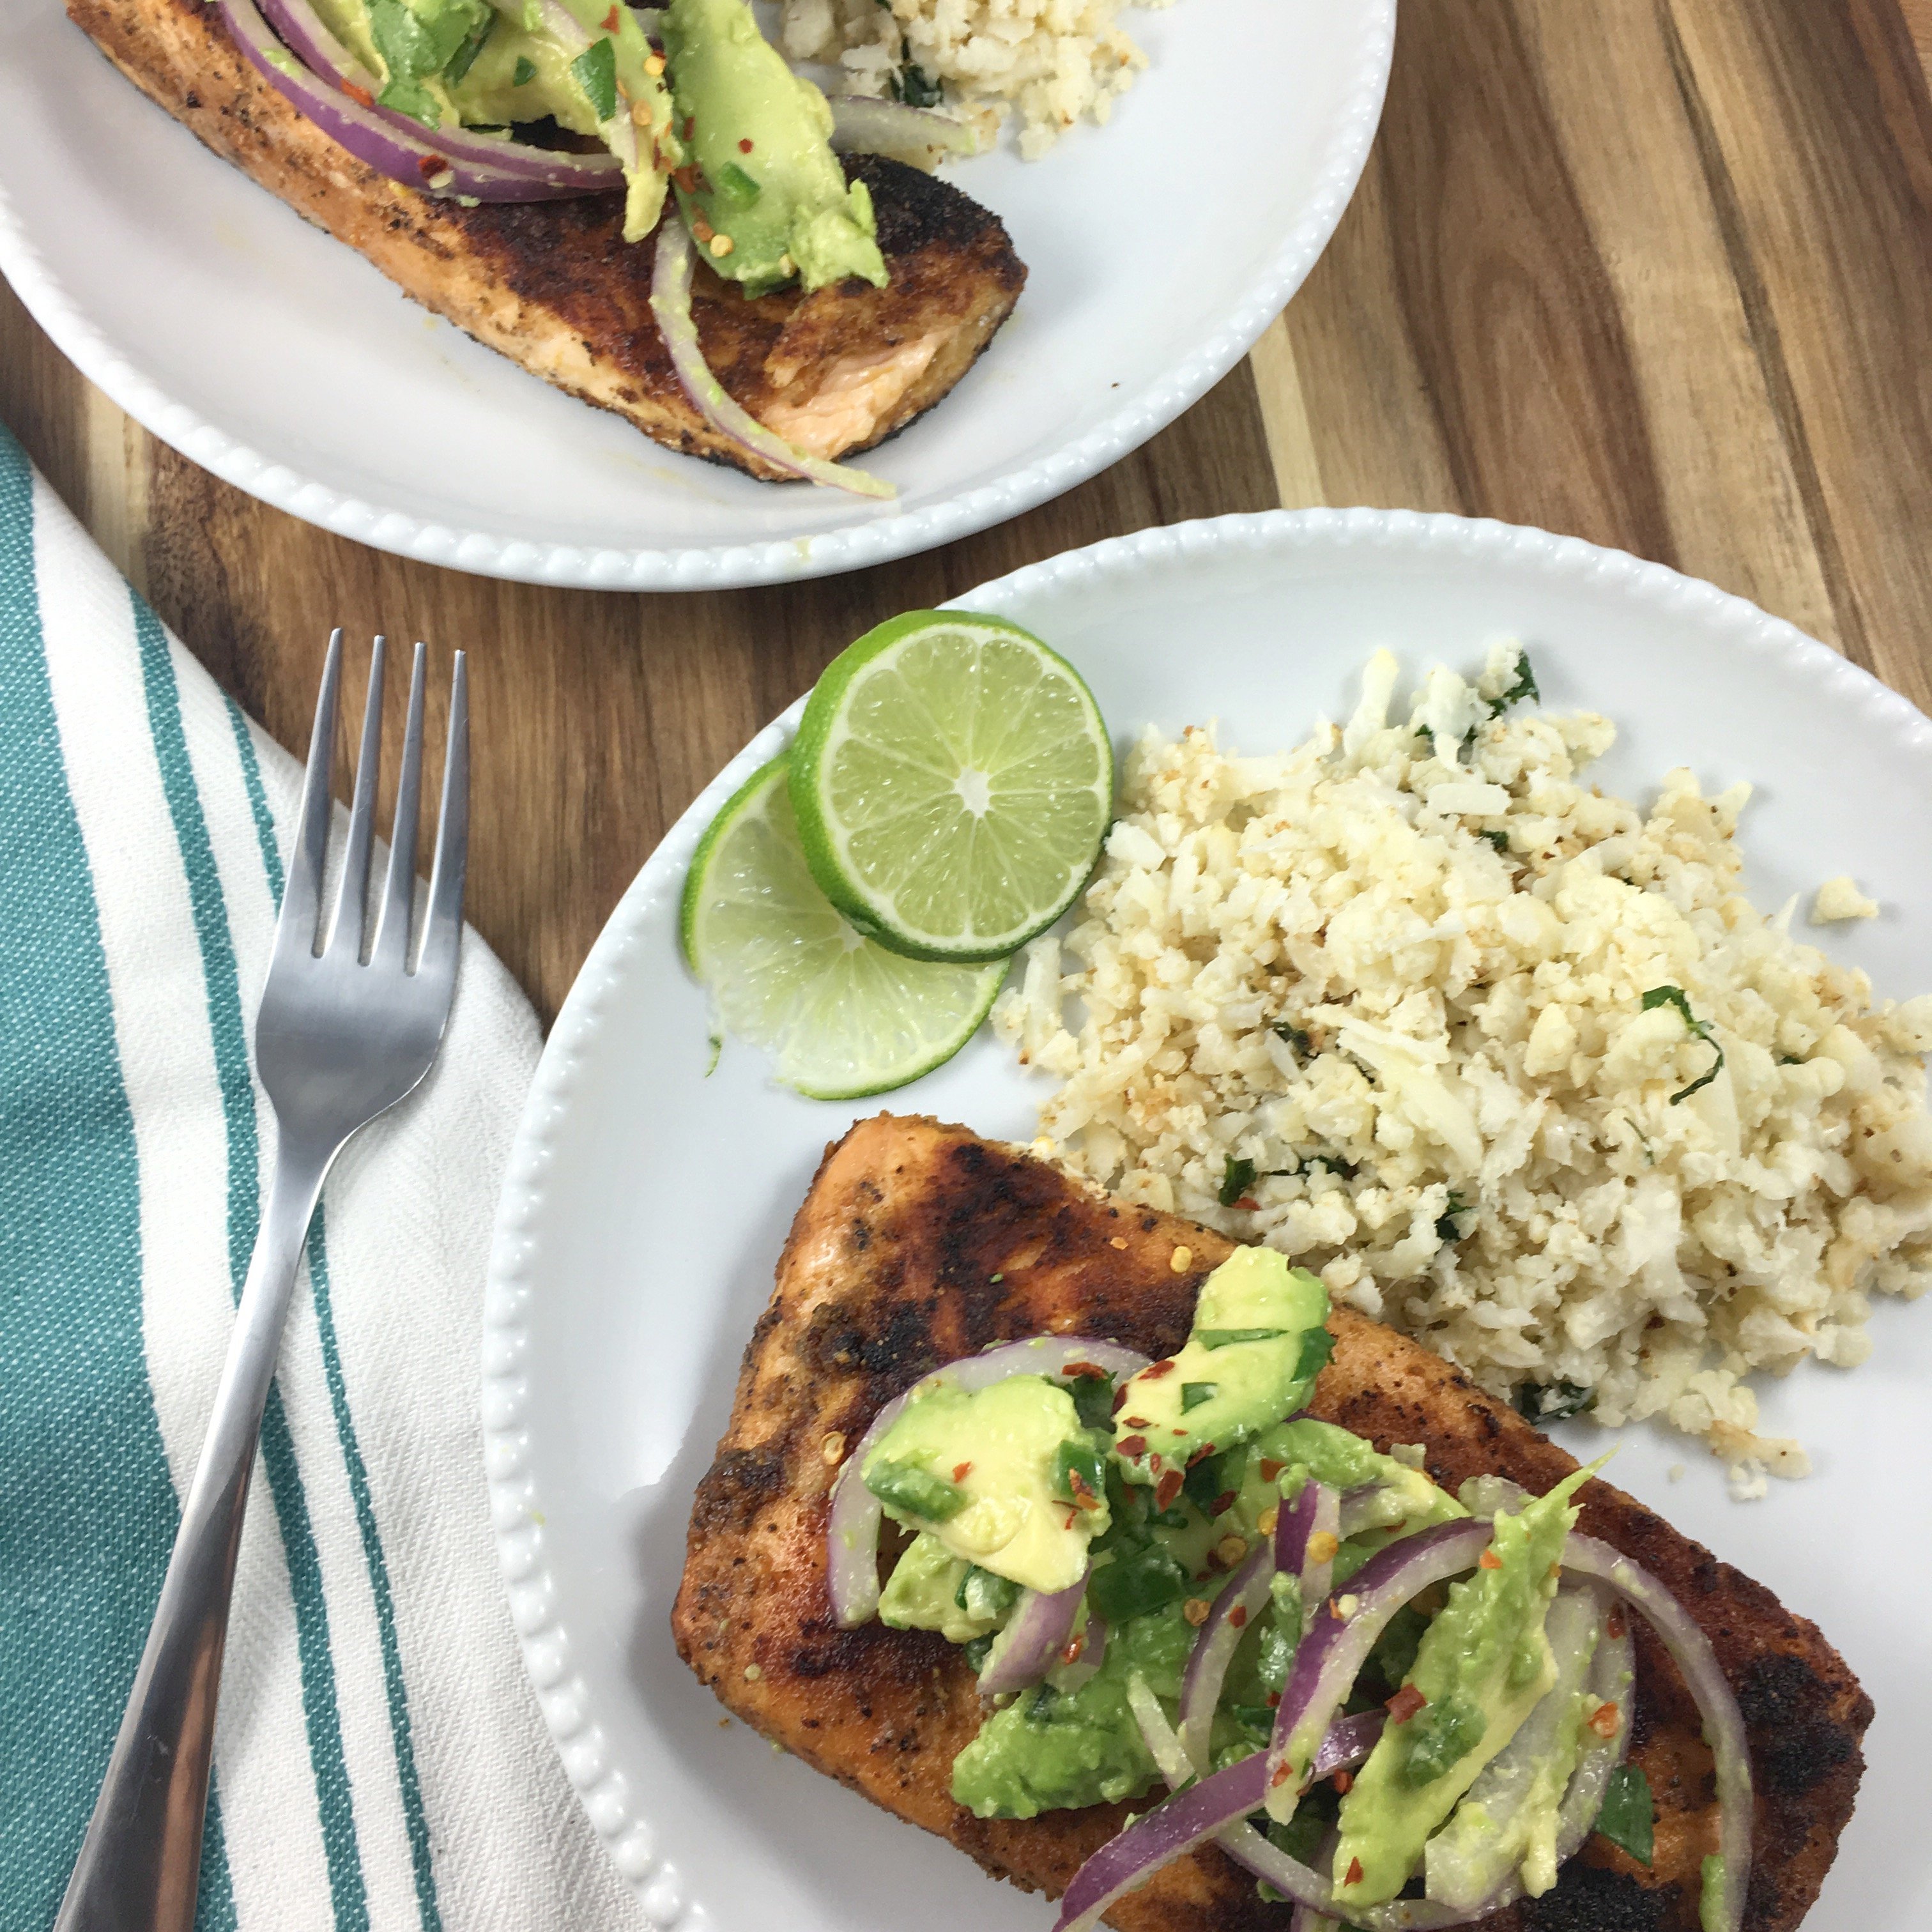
[[792, 611, 1113, 960]]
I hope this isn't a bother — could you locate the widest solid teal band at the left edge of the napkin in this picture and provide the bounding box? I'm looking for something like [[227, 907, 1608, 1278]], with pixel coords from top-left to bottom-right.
[[0, 429, 236, 1932]]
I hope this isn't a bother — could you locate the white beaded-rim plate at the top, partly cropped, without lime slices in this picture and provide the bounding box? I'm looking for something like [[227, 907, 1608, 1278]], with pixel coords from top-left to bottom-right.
[[0, 0, 1395, 589]]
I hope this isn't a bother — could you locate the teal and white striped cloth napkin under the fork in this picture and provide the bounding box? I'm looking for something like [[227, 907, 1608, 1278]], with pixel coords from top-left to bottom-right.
[[0, 429, 643, 1932]]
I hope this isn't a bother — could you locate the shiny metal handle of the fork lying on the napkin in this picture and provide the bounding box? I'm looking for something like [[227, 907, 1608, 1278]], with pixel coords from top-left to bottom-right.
[[54, 1140, 340, 1932]]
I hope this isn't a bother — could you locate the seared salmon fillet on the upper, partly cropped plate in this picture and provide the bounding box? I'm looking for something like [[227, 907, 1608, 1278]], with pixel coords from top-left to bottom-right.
[[68, 0, 1026, 481]]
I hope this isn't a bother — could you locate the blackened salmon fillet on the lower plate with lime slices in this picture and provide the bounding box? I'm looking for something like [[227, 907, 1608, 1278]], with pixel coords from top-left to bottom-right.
[[672, 1115, 1872, 1932]]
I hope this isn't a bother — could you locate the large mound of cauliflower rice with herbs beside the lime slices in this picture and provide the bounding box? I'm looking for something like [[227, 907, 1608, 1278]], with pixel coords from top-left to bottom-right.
[[997, 649, 1932, 1496]]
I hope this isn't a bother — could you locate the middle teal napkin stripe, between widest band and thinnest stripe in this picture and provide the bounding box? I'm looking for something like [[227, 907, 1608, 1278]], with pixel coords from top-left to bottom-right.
[[130, 591, 369, 1932]]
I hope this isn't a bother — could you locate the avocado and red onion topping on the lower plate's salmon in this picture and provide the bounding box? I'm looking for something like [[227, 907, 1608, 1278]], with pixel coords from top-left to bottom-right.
[[831, 1248, 1751, 1932]]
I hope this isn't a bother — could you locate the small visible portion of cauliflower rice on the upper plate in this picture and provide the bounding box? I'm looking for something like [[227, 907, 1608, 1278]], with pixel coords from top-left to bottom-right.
[[779, 0, 1171, 160]]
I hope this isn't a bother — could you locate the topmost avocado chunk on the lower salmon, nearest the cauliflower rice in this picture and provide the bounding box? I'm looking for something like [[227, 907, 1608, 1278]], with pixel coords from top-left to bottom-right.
[[1113, 1248, 1327, 1482]]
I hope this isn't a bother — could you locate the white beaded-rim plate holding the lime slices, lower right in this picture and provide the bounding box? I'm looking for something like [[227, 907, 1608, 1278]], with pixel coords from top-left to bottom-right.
[[485, 510, 1932, 1932]]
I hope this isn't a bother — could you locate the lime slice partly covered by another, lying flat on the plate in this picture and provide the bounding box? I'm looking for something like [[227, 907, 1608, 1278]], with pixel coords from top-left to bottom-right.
[[678, 757, 1004, 1100]]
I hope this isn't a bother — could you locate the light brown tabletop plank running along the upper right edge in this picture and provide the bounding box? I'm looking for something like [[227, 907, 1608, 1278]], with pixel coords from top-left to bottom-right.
[[1669, 0, 1932, 705]]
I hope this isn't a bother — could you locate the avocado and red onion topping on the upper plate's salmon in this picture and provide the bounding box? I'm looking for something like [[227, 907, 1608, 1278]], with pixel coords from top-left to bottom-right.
[[218, 0, 931, 496]]
